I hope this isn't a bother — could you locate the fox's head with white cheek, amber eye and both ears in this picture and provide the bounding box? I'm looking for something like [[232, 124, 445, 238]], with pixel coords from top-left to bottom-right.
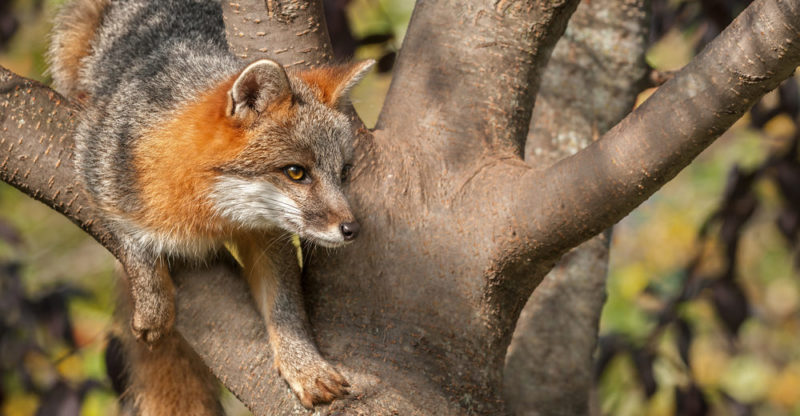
[[212, 59, 374, 247]]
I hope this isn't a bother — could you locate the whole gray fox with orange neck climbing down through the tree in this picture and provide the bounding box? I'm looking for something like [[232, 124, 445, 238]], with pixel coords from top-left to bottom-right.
[[49, 0, 373, 414]]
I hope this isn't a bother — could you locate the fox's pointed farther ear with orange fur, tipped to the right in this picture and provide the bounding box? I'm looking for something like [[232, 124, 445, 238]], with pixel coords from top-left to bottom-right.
[[298, 59, 375, 108]]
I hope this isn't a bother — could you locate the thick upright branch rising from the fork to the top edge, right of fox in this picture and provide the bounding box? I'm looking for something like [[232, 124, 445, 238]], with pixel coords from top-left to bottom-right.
[[377, 0, 578, 161]]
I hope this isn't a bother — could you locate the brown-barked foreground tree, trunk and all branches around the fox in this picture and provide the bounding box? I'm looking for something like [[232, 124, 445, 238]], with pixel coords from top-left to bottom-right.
[[0, 0, 800, 415]]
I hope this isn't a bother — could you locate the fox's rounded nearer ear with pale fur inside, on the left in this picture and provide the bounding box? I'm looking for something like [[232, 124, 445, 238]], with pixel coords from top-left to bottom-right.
[[227, 59, 292, 125]]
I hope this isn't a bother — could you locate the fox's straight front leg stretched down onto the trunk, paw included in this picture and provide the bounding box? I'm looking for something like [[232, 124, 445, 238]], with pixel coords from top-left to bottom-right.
[[235, 233, 349, 408]]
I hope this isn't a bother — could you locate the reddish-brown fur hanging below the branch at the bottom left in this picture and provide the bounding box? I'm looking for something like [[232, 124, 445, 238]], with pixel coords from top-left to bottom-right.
[[110, 268, 224, 416]]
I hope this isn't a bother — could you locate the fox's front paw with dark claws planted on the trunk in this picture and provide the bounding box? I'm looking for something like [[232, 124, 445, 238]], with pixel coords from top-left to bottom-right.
[[278, 357, 350, 409]]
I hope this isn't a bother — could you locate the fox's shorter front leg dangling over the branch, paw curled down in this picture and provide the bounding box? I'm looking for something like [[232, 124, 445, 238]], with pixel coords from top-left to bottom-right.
[[123, 245, 175, 346]]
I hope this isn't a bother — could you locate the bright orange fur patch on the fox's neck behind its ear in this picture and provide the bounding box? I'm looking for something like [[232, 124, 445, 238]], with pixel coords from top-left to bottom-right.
[[135, 78, 248, 244]]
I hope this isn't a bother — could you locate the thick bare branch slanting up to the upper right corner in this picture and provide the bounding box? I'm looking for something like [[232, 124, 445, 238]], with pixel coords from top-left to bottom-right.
[[510, 0, 800, 264]]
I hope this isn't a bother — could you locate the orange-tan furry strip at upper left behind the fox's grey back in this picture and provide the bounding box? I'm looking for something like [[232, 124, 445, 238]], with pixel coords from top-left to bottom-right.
[[47, 0, 110, 99]]
